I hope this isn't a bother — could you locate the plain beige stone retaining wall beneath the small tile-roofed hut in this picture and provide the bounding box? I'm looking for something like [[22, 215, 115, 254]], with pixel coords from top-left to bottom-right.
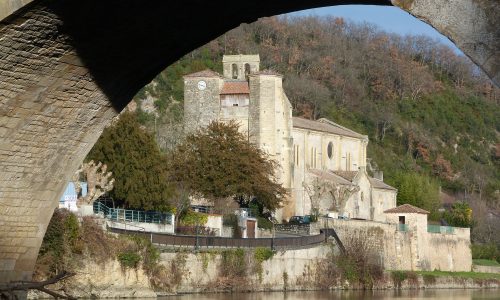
[[322, 219, 472, 272]]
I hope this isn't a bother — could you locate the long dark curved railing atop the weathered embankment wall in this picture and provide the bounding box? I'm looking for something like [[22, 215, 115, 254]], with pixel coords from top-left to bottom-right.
[[108, 228, 326, 249]]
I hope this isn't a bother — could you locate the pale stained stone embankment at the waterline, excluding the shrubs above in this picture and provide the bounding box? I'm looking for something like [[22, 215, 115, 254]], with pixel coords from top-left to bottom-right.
[[28, 245, 500, 299]]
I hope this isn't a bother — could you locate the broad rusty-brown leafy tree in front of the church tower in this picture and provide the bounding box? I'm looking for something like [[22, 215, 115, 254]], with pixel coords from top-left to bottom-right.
[[171, 121, 286, 211]]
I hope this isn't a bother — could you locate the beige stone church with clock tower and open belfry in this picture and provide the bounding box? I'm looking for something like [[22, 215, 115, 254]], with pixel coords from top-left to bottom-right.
[[184, 55, 397, 222]]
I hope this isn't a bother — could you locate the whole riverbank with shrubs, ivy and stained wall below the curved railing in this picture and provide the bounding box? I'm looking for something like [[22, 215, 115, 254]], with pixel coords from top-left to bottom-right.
[[29, 212, 500, 299]]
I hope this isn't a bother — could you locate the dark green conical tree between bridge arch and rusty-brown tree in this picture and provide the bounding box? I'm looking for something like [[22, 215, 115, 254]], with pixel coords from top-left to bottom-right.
[[87, 112, 174, 211]]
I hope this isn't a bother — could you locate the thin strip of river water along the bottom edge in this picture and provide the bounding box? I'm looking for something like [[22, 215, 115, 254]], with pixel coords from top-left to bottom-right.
[[159, 289, 500, 300]]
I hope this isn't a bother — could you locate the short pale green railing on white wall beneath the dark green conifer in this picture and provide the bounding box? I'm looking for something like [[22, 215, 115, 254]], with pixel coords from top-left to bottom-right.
[[93, 201, 172, 224]]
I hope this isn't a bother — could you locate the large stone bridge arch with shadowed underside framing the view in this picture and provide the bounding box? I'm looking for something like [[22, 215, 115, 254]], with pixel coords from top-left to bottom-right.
[[0, 0, 500, 283]]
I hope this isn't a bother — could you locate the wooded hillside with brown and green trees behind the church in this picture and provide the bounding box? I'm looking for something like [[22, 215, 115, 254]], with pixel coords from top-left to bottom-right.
[[135, 17, 500, 239]]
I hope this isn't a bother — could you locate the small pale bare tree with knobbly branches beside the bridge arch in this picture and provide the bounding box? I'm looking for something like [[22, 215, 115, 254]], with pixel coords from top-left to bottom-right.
[[73, 160, 115, 206]]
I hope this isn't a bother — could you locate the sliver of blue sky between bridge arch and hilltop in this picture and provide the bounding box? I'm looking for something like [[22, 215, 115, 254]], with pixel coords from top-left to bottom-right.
[[289, 5, 462, 54]]
